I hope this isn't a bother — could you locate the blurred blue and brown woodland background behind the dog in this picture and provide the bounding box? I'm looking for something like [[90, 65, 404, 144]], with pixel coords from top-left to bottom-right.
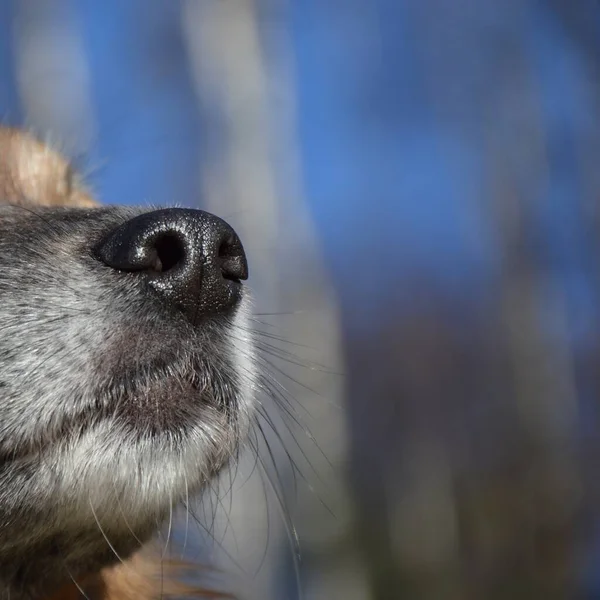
[[0, 0, 600, 600]]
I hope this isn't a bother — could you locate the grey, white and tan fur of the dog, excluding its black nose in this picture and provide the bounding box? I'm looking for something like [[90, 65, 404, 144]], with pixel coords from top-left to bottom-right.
[[0, 128, 254, 600]]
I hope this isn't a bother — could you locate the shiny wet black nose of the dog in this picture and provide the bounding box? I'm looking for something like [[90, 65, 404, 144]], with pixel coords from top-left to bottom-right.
[[96, 208, 248, 323]]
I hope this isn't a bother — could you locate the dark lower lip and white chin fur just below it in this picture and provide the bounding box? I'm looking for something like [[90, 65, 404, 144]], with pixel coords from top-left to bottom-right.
[[48, 373, 249, 478]]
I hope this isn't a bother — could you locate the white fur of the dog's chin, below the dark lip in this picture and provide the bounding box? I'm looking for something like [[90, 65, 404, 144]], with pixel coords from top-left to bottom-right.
[[7, 396, 246, 552]]
